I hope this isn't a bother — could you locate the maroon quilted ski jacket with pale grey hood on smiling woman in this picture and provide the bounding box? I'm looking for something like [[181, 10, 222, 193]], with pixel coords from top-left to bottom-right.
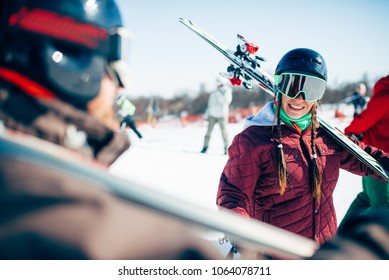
[[217, 102, 389, 244]]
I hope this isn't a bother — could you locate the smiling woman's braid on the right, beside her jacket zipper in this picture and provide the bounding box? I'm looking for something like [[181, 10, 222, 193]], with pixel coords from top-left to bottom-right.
[[311, 102, 322, 203]]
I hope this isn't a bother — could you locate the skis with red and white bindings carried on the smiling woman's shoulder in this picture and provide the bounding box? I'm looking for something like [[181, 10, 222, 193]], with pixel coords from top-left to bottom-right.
[[179, 18, 389, 182]]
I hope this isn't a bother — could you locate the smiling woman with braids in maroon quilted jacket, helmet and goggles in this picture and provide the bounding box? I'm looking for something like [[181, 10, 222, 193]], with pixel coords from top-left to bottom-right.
[[217, 49, 389, 244]]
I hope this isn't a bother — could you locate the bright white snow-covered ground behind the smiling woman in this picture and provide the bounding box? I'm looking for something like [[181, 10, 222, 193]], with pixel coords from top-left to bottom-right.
[[110, 106, 362, 255]]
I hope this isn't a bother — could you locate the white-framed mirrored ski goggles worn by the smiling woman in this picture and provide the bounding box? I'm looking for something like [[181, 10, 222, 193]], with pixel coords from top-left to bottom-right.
[[274, 73, 326, 102]]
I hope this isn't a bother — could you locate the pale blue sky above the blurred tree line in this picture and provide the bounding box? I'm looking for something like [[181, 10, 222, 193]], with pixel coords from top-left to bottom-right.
[[117, 0, 389, 97]]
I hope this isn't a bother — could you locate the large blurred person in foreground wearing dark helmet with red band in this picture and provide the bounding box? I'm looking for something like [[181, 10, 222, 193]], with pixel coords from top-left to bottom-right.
[[0, 0, 219, 259]]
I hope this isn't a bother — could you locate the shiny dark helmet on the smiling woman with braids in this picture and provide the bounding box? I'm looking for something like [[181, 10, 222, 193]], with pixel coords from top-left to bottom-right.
[[275, 48, 327, 81]]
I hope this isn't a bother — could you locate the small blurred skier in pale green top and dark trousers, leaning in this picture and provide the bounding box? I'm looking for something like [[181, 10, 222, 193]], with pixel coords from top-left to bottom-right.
[[116, 94, 142, 139]]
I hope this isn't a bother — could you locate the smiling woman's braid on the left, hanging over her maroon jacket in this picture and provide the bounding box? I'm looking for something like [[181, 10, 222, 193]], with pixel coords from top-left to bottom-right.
[[276, 94, 287, 195]]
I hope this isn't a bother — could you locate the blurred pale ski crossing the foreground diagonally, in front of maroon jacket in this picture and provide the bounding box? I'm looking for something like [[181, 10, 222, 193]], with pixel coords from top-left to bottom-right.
[[0, 133, 318, 259]]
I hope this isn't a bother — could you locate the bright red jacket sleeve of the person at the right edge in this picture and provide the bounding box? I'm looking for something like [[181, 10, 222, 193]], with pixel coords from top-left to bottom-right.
[[344, 97, 389, 135]]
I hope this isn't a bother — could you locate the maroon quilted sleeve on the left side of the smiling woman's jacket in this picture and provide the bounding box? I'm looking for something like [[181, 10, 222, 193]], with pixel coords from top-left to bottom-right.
[[216, 134, 260, 217]]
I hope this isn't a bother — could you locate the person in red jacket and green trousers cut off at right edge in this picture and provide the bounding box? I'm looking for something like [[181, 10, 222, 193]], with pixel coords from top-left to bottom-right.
[[344, 76, 389, 224]]
